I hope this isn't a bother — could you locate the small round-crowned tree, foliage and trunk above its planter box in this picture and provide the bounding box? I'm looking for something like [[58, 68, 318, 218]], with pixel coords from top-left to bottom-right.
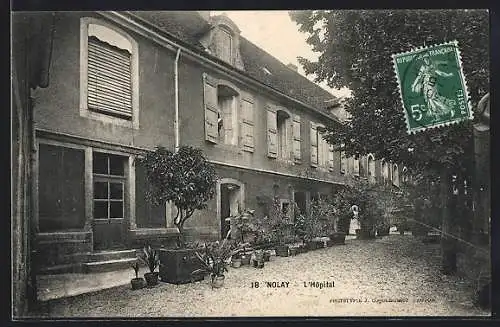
[[139, 146, 217, 247]]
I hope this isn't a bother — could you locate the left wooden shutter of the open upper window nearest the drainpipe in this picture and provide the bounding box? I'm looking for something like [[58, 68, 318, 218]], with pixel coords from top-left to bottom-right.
[[203, 75, 219, 143]]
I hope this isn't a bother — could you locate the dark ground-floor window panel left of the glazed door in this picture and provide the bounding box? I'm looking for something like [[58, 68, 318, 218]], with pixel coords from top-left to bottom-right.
[[38, 143, 85, 232]]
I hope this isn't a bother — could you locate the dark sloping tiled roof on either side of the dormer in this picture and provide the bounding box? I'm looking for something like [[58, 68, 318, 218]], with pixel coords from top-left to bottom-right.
[[132, 11, 338, 113]]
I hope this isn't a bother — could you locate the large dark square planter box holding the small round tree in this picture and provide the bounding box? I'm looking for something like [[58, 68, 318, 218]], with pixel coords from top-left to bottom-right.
[[159, 249, 205, 284]]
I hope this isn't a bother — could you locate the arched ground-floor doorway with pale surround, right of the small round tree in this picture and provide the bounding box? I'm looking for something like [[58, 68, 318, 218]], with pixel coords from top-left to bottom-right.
[[217, 178, 245, 239]]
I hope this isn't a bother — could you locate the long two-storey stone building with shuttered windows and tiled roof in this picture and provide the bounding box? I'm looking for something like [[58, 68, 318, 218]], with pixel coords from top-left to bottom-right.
[[11, 11, 401, 273]]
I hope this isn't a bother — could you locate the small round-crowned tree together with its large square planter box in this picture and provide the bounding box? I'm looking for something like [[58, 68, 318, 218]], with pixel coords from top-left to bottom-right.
[[138, 146, 217, 284]]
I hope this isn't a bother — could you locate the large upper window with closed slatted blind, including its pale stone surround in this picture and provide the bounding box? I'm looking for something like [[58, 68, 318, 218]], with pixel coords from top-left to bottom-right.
[[80, 17, 139, 128]]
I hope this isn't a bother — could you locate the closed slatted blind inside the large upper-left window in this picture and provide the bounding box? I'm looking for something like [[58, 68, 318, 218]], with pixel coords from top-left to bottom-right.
[[87, 36, 132, 118]]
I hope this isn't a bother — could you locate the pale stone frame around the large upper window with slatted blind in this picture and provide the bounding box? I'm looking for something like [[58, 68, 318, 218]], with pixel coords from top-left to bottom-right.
[[79, 17, 139, 129]]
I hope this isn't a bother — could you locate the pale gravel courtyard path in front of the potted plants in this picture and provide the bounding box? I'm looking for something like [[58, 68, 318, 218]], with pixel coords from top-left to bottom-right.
[[31, 235, 490, 317]]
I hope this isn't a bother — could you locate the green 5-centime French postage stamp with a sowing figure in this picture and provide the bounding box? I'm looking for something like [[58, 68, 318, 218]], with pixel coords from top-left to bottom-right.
[[392, 41, 473, 134]]
